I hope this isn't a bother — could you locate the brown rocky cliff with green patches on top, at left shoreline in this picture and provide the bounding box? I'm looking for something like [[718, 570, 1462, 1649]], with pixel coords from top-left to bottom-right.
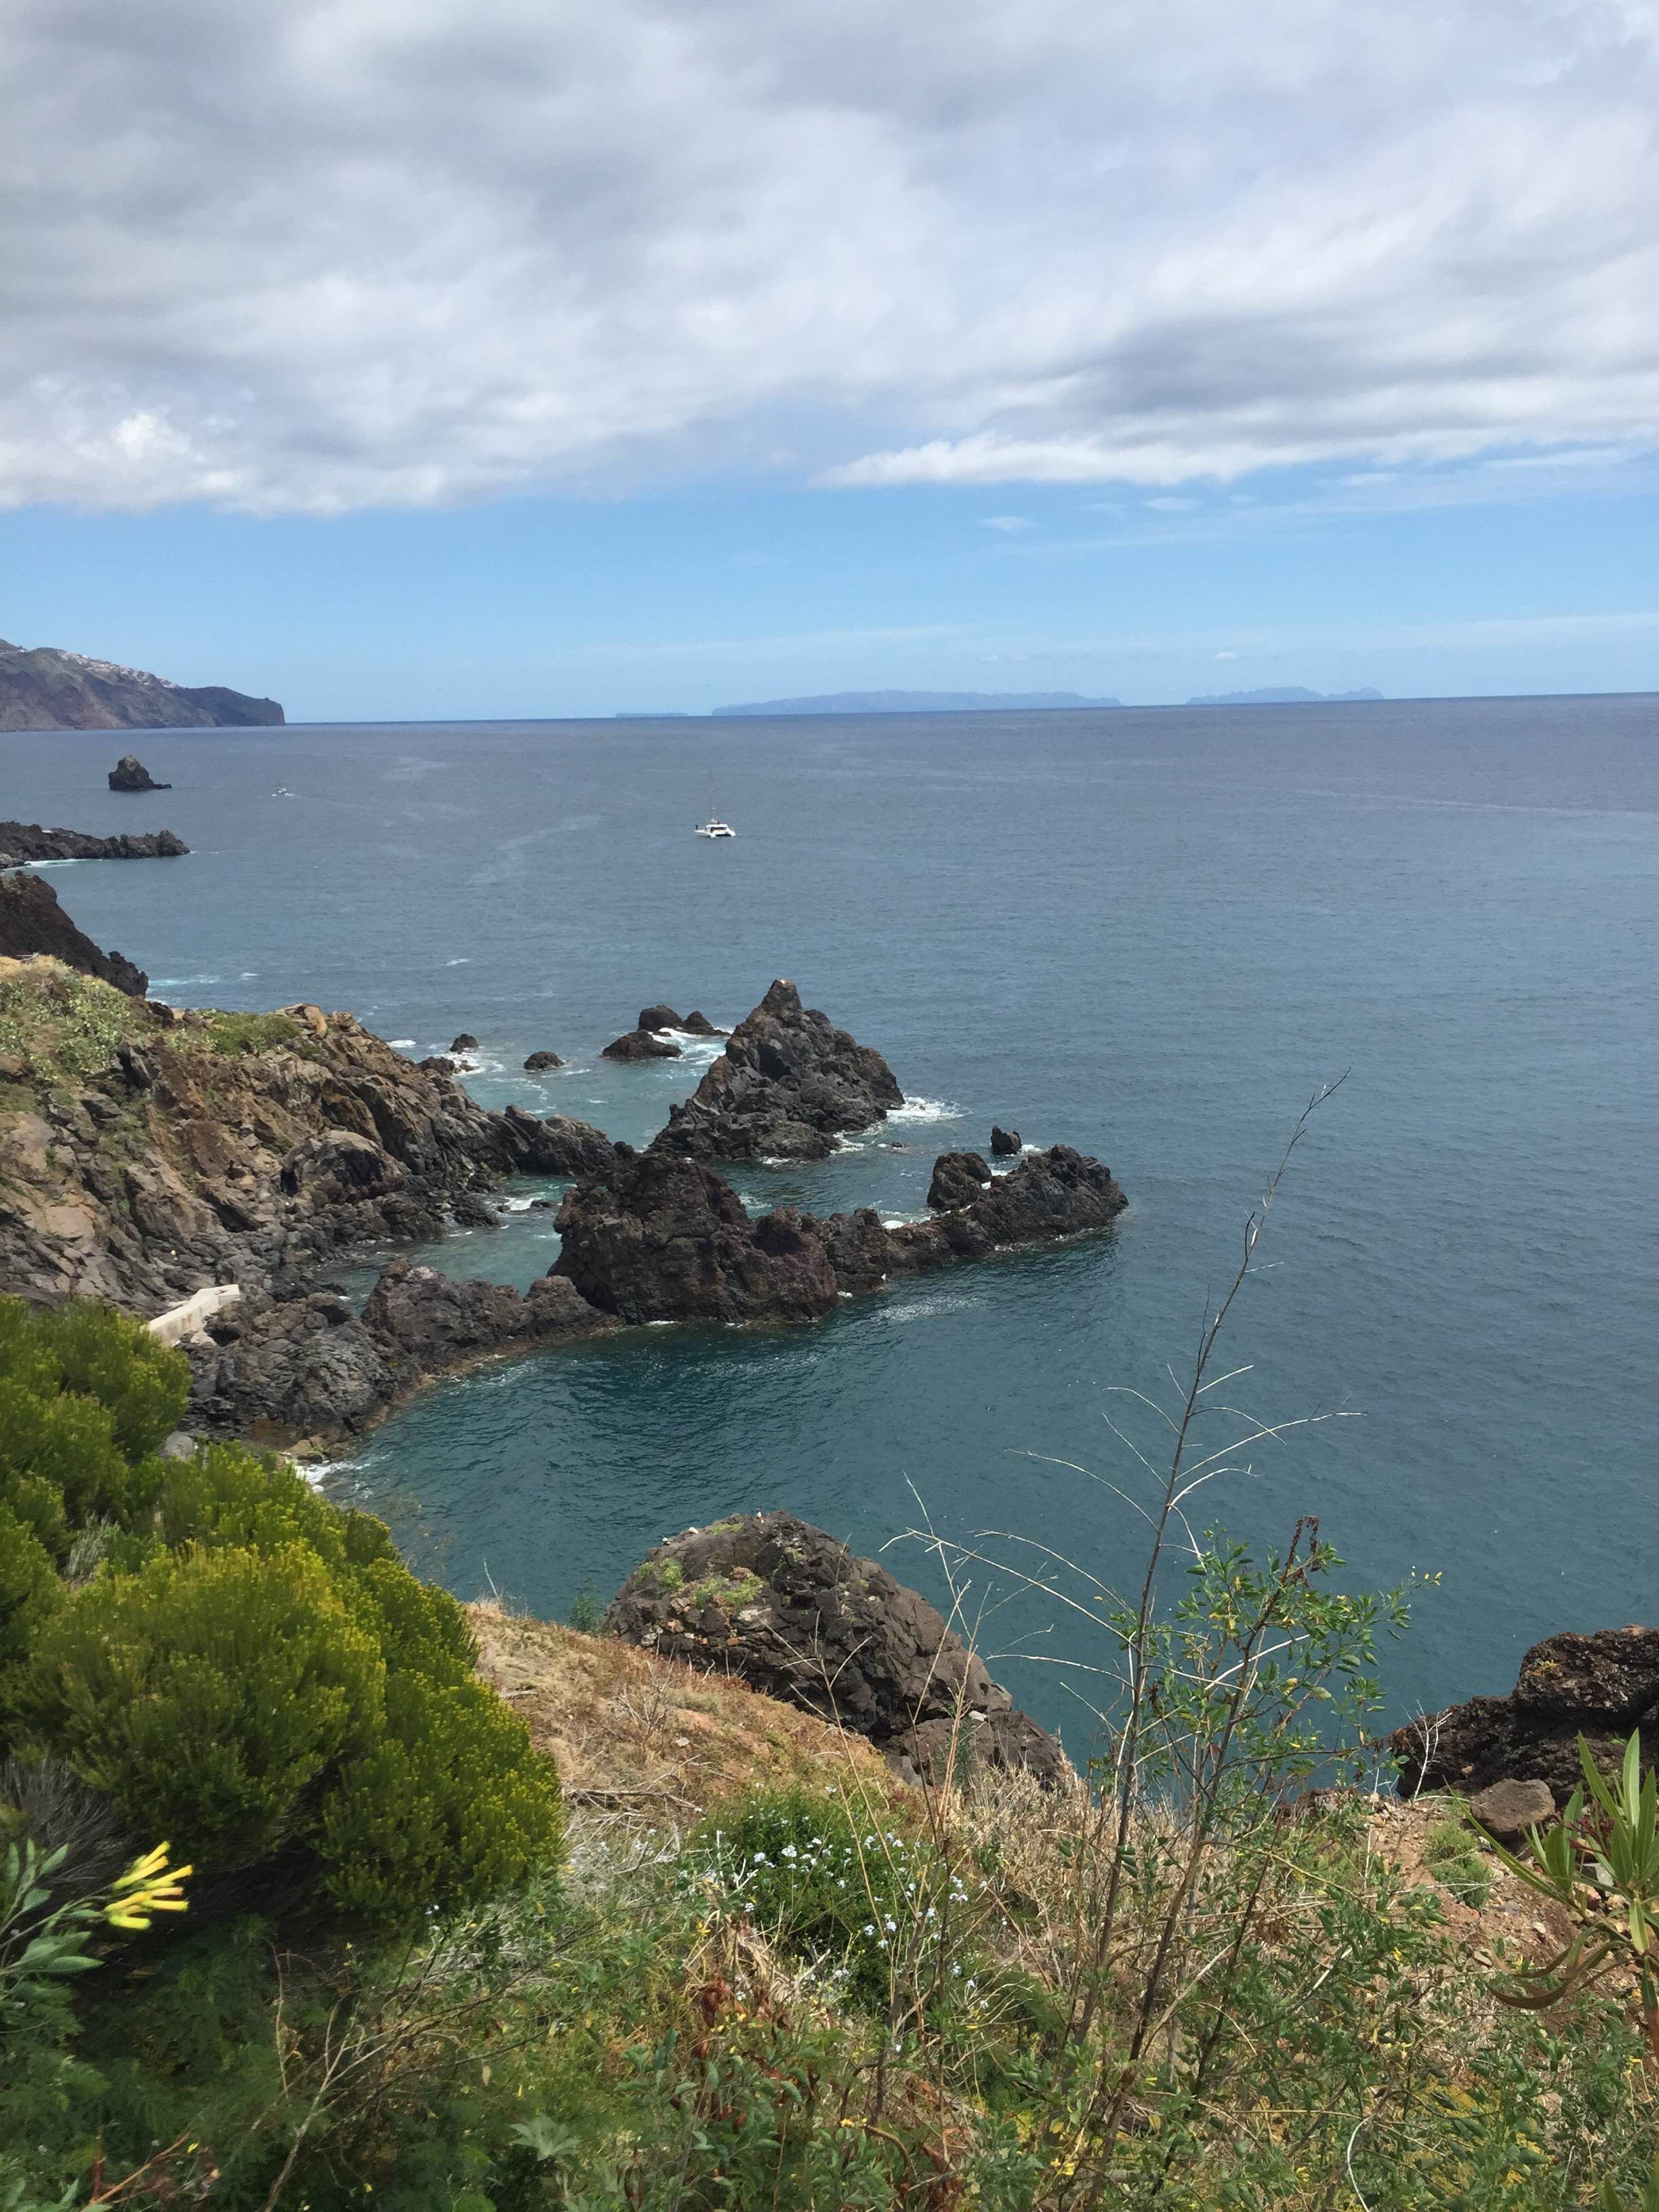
[[0, 956, 611, 1314]]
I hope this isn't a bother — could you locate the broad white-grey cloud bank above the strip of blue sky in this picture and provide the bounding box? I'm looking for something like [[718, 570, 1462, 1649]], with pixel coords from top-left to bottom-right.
[[0, 0, 1659, 506]]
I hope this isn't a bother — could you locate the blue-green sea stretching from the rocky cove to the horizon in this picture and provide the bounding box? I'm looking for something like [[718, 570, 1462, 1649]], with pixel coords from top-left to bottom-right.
[[0, 697, 1659, 1719]]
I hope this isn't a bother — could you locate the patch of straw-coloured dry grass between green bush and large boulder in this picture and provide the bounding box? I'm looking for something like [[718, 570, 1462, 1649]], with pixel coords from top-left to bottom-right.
[[467, 1599, 903, 1862]]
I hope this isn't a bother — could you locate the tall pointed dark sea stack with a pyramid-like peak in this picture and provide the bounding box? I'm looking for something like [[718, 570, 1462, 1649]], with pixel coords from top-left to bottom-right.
[[653, 980, 905, 1159]]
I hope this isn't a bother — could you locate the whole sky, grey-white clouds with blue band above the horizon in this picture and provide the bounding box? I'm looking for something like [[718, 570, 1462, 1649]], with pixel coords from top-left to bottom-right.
[[0, 0, 1659, 719]]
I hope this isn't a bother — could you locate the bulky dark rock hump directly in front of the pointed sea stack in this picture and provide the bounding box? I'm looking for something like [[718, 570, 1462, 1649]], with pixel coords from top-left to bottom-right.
[[553, 1146, 838, 1321]]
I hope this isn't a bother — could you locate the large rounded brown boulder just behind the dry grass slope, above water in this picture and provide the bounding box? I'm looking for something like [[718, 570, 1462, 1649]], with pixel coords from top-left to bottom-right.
[[604, 1513, 1069, 1783]]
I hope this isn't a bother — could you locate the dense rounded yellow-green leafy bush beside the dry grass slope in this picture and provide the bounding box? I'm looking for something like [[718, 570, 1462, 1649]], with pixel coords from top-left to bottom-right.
[[0, 1300, 562, 1918]]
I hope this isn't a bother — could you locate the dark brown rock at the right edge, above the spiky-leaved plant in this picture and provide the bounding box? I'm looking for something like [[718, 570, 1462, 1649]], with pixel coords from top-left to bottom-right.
[[1389, 1628, 1659, 1803]]
